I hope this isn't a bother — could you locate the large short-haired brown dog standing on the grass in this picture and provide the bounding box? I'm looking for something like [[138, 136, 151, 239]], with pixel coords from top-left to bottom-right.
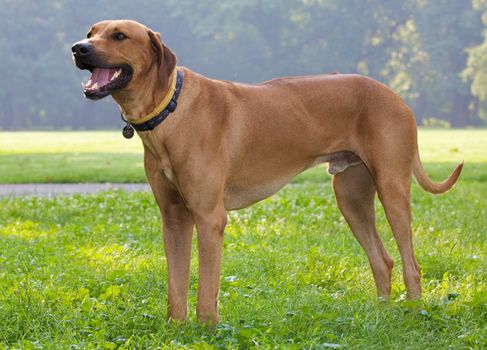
[[72, 20, 462, 322]]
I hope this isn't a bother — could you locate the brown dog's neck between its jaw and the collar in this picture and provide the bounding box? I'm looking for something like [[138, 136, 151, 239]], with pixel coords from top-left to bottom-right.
[[112, 66, 170, 122]]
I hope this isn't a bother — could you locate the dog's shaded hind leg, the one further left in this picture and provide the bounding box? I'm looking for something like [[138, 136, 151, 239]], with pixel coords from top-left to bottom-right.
[[333, 163, 394, 299]]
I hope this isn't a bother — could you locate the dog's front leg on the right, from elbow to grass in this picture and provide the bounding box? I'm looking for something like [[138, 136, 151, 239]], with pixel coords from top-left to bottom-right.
[[195, 204, 227, 324]]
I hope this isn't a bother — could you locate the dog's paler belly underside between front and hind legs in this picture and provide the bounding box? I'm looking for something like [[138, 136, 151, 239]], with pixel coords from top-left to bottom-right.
[[224, 151, 362, 210]]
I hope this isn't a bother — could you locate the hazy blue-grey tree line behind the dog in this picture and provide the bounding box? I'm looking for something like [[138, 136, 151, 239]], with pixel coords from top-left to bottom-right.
[[0, 0, 487, 130]]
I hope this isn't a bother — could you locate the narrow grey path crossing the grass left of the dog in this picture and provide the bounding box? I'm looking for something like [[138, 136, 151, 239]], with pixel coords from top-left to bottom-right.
[[0, 183, 150, 197]]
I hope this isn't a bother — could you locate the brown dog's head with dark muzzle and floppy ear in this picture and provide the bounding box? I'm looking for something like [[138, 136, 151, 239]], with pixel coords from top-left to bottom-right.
[[71, 20, 176, 100]]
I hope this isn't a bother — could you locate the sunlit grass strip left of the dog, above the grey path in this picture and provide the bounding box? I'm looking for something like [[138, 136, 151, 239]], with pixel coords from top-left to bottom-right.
[[0, 131, 146, 183]]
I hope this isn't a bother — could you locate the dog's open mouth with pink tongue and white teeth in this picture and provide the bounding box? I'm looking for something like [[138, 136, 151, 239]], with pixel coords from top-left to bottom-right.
[[81, 65, 132, 99]]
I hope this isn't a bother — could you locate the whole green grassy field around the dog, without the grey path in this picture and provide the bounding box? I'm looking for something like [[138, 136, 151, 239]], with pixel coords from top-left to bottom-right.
[[0, 130, 487, 349]]
